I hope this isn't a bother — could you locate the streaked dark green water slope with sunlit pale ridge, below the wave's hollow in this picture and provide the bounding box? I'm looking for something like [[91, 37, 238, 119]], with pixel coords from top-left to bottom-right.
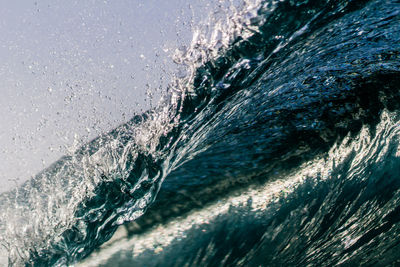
[[78, 109, 400, 266]]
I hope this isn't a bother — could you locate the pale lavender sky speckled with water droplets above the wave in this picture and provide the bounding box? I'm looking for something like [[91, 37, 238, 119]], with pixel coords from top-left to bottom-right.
[[0, 0, 216, 192]]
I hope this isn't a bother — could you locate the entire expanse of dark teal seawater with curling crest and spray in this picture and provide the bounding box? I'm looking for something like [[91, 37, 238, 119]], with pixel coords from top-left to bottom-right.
[[0, 0, 400, 266]]
